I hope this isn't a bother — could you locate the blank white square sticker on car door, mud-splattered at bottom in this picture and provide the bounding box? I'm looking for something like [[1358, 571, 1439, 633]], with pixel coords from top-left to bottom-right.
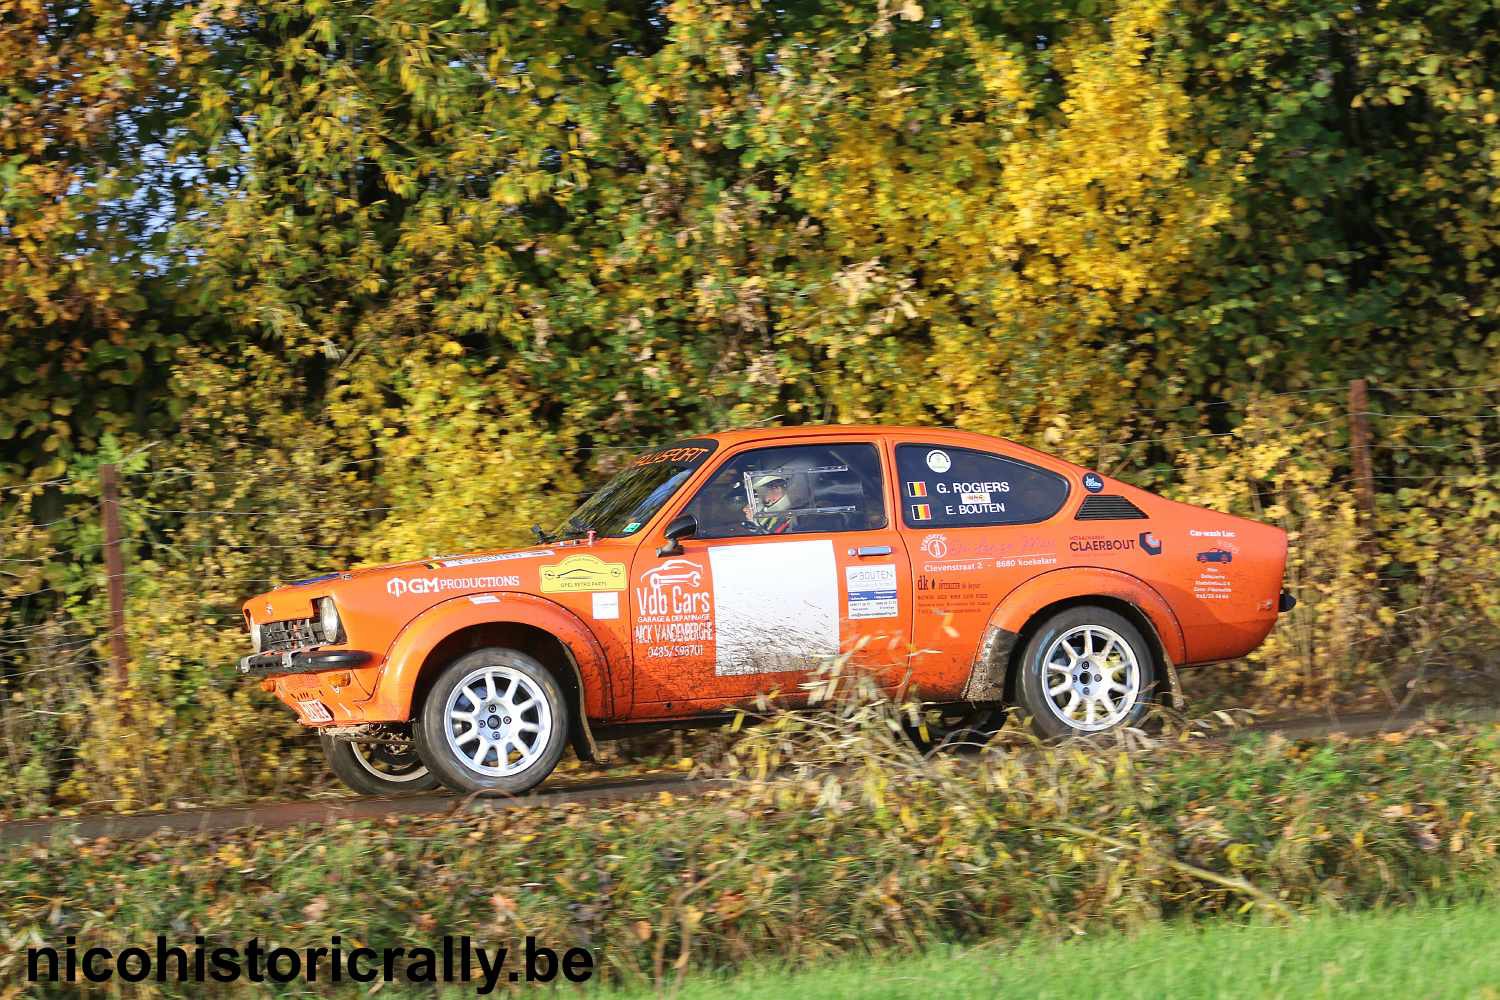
[[708, 538, 839, 676]]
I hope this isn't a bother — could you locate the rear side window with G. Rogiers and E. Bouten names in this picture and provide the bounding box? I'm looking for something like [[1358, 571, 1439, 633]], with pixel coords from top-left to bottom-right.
[[896, 444, 1068, 528]]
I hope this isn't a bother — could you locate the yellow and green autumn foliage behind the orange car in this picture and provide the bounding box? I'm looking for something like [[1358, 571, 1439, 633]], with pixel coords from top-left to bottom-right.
[[0, 0, 1500, 810]]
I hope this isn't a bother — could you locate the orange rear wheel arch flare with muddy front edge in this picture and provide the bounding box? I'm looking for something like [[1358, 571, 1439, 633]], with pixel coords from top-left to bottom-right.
[[963, 568, 1185, 708]]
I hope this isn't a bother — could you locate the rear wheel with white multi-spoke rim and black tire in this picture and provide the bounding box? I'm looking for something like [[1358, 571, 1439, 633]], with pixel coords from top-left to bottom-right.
[[1016, 606, 1158, 738]]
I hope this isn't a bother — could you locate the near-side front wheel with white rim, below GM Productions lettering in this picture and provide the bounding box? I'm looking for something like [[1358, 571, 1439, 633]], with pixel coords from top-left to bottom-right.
[[413, 648, 572, 795]]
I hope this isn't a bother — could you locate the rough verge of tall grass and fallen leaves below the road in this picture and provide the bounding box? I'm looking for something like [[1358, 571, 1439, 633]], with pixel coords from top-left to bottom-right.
[[0, 681, 1500, 984]]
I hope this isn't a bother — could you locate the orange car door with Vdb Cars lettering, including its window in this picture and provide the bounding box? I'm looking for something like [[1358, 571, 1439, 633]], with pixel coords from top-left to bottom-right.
[[630, 436, 914, 717]]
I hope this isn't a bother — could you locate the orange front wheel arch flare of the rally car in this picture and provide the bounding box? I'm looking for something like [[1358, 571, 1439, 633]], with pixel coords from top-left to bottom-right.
[[368, 592, 614, 760]]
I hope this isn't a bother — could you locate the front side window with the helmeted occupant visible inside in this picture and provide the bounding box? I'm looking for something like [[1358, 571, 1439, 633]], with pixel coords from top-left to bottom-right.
[[684, 444, 887, 538]]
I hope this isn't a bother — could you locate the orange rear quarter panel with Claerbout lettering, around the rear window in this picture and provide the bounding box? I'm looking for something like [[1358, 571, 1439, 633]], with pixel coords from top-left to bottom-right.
[[891, 432, 1287, 697]]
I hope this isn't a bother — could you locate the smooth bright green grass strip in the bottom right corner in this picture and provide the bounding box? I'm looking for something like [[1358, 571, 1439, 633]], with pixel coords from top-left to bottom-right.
[[594, 901, 1500, 1000]]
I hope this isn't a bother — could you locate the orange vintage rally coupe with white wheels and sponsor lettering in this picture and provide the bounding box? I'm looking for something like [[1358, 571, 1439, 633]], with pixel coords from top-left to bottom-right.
[[240, 427, 1293, 793]]
